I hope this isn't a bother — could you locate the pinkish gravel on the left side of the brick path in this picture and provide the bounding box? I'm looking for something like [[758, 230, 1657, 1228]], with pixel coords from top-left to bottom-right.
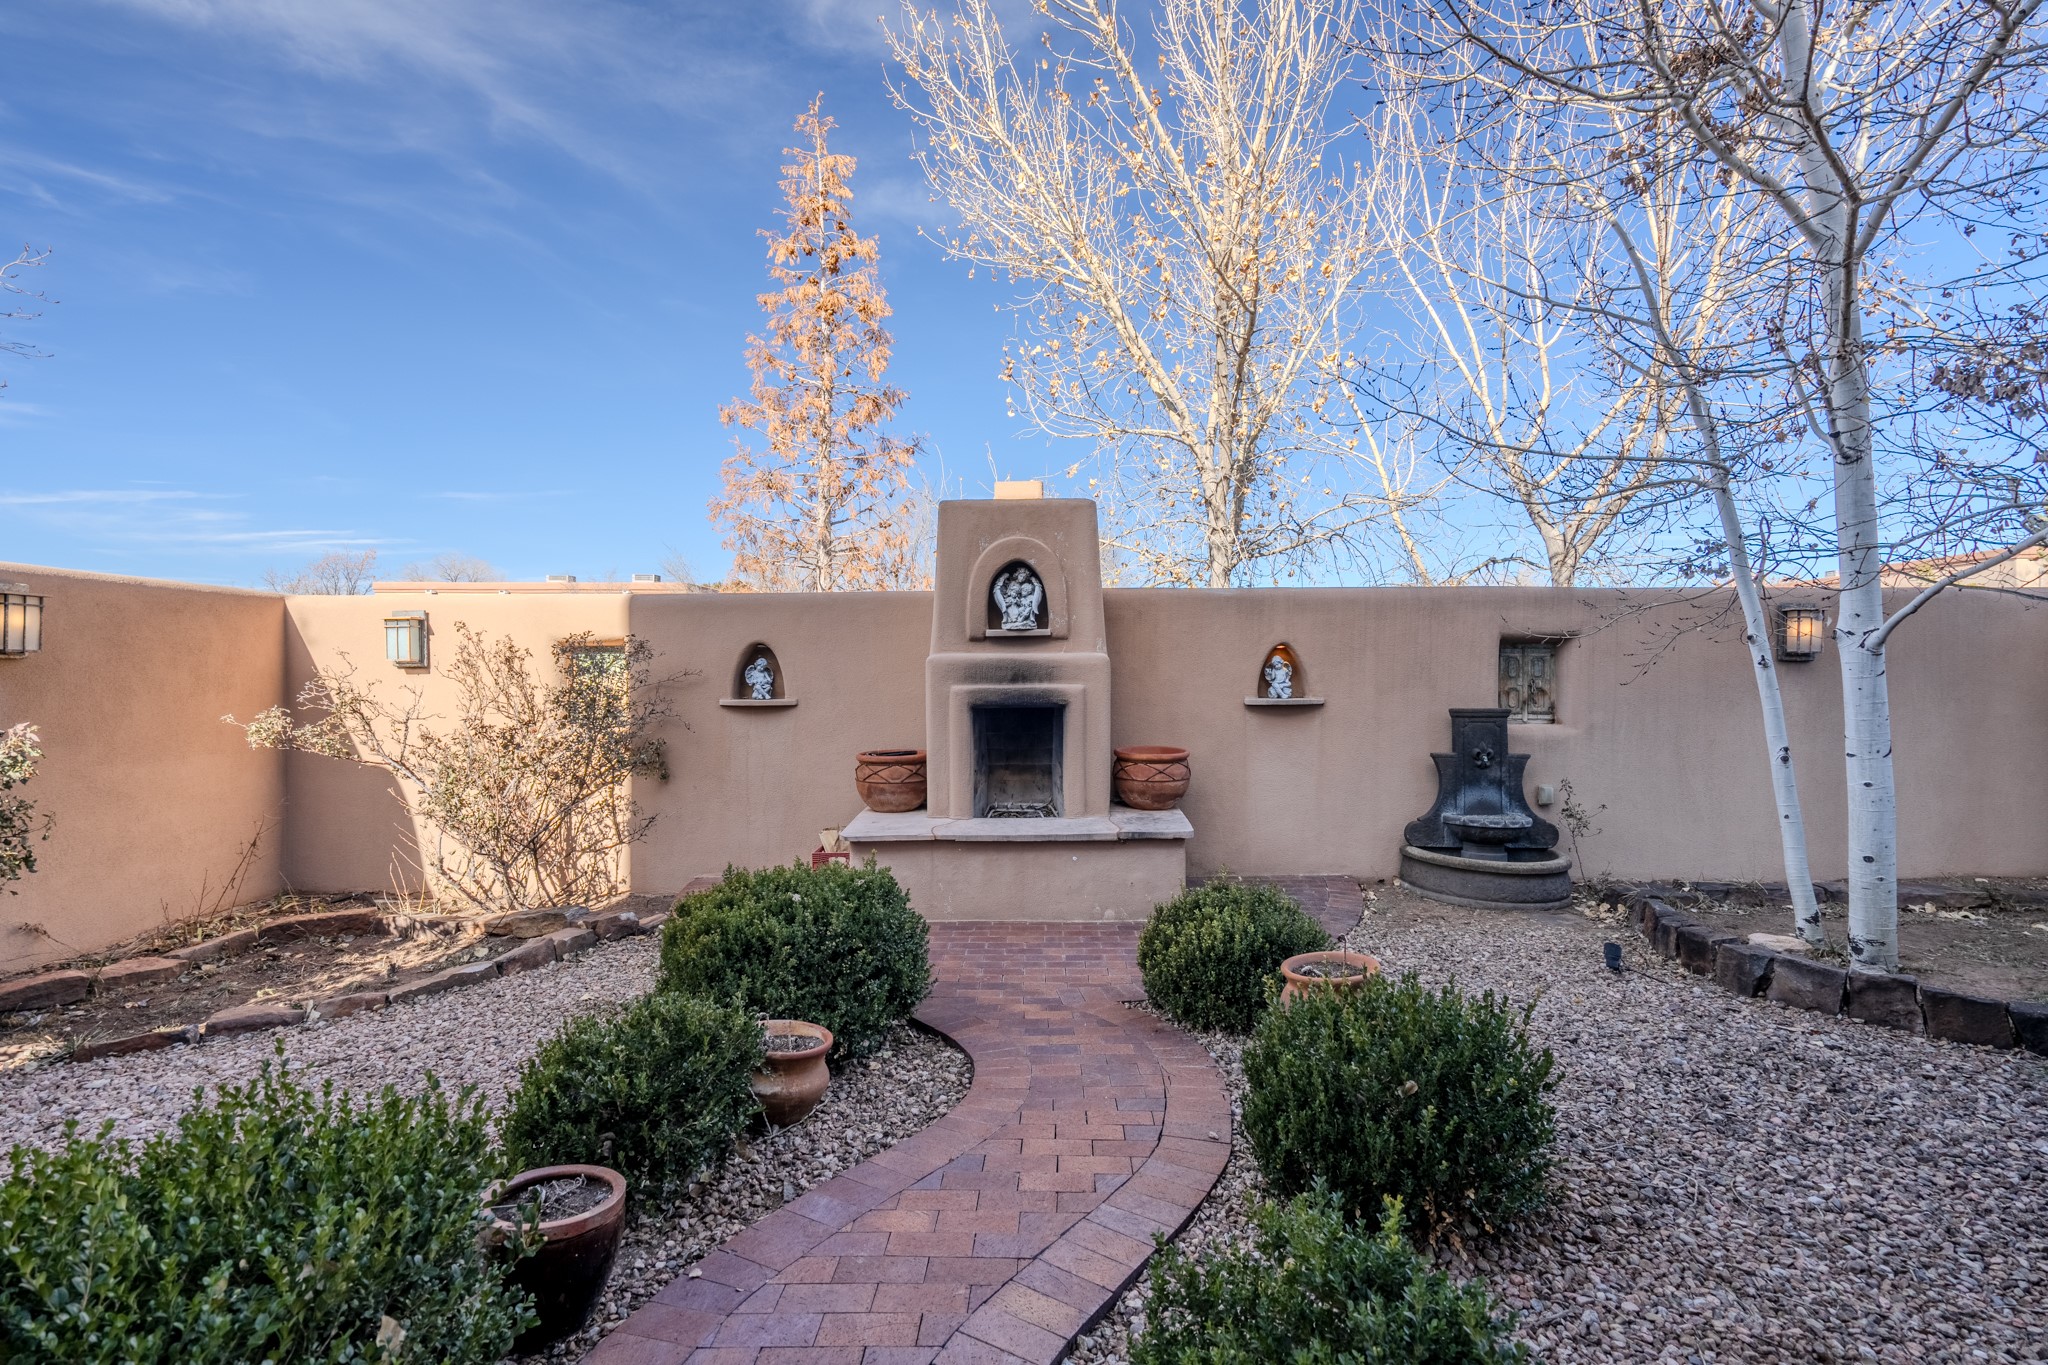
[[0, 937, 973, 1359]]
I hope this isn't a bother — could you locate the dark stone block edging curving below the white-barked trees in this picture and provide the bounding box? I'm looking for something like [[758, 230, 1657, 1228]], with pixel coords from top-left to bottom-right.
[[1622, 892, 2048, 1056]]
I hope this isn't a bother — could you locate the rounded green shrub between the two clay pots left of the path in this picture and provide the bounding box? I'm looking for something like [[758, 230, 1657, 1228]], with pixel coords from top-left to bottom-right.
[[504, 995, 762, 1197]]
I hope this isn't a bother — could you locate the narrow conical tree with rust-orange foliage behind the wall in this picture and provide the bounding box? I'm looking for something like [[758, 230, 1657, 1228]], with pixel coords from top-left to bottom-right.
[[711, 96, 930, 591]]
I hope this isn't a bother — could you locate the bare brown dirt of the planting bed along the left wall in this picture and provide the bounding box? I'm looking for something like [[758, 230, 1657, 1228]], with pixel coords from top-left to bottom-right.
[[0, 896, 674, 1070]]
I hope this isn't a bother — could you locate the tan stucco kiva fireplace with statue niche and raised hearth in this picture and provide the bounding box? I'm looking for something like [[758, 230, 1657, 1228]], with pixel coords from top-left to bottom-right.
[[846, 497, 1194, 919]]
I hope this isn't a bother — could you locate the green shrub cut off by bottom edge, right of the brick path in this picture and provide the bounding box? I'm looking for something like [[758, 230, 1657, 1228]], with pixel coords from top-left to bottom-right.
[[1130, 1187, 1530, 1365]]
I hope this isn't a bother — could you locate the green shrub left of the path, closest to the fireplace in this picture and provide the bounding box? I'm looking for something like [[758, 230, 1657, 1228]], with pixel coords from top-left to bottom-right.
[[662, 857, 932, 1060]]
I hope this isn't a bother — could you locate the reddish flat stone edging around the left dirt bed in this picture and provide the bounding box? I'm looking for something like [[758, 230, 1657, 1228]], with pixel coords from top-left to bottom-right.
[[0, 909, 668, 1062]]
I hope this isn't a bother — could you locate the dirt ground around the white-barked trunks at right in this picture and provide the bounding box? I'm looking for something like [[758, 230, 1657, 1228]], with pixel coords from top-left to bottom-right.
[[1597, 878, 2048, 1001]]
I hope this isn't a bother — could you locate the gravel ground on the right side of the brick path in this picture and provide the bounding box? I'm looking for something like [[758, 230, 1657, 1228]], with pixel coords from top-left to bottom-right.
[[1071, 888, 2048, 1365]]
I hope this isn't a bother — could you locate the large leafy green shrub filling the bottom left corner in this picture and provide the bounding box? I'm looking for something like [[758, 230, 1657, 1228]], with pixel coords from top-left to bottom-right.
[[0, 1066, 532, 1365]]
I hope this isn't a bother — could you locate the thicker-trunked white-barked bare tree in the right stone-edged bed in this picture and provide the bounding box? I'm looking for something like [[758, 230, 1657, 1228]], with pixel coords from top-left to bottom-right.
[[1413, 0, 2048, 970]]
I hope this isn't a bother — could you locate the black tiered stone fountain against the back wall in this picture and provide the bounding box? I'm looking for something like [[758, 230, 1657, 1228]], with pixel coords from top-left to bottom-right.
[[1401, 706, 1571, 911]]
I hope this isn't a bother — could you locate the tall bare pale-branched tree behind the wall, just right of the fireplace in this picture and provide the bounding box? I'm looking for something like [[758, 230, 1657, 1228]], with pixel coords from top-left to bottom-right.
[[889, 0, 1386, 587]]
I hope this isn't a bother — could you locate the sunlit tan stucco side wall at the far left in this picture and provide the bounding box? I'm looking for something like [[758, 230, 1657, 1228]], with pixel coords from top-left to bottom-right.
[[0, 563, 285, 972]]
